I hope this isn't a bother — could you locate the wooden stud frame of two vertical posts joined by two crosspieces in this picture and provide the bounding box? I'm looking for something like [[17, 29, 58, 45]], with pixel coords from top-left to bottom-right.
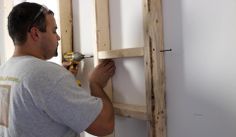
[[95, 0, 167, 137]]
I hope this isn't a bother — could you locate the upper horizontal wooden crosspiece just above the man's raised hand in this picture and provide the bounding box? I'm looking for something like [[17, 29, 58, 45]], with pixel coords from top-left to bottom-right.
[[98, 47, 144, 59]]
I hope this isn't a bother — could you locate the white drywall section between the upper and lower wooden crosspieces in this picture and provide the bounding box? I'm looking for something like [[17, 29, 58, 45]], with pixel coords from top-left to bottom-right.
[[112, 58, 146, 106]]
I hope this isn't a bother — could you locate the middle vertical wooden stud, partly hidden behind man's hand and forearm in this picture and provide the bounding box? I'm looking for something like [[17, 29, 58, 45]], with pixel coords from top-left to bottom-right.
[[94, 0, 115, 137]]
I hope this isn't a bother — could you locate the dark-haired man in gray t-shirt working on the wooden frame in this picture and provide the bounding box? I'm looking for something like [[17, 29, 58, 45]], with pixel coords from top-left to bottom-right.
[[0, 2, 115, 137]]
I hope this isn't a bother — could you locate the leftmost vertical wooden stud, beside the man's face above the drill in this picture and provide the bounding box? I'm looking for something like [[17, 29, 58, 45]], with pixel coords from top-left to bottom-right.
[[59, 0, 73, 54]]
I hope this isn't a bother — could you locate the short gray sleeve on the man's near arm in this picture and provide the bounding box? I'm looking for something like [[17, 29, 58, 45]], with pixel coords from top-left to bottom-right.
[[40, 75, 103, 133]]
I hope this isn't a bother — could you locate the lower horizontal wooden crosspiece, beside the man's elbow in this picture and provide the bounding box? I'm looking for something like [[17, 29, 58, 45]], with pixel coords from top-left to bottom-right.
[[113, 103, 148, 120]]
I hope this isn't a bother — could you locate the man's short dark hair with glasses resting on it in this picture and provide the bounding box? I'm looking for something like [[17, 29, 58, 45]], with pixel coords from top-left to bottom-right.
[[8, 2, 54, 44]]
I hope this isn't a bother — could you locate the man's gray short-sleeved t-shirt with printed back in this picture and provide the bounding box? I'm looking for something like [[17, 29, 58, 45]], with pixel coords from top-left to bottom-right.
[[0, 56, 102, 137]]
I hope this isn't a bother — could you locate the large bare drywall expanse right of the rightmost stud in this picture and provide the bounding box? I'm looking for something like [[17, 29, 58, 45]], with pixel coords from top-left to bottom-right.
[[163, 0, 236, 137]]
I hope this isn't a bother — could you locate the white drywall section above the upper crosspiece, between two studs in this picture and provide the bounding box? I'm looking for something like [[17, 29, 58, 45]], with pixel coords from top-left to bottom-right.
[[109, 0, 144, 49]]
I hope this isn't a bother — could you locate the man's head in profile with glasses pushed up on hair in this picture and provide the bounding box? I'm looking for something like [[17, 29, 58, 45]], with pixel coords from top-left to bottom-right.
[[8, 2, 60, 59]]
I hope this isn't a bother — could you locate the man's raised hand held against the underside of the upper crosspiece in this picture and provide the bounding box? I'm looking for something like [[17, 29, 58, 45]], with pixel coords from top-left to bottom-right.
[[89, 59, 116, 88]]
